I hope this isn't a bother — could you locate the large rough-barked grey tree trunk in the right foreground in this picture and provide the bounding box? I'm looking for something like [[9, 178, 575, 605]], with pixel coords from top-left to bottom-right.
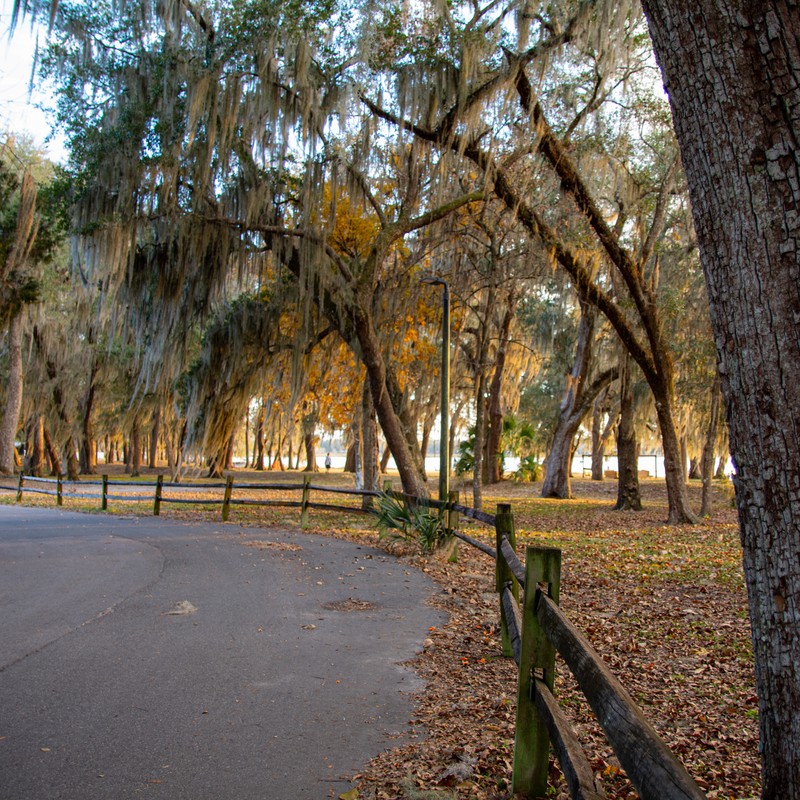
[[643, 0, 800, 800]]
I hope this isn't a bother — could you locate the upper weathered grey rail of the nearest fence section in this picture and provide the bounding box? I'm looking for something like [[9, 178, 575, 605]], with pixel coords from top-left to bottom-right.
[[536, 592, 705, 800]]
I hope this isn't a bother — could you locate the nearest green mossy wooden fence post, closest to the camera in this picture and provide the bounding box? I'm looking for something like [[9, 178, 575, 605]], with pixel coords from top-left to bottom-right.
[[512, 548, 561, 798]]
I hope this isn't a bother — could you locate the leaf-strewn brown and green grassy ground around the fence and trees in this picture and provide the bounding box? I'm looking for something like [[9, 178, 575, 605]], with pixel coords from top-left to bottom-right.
[[0, 468, 759, 800]]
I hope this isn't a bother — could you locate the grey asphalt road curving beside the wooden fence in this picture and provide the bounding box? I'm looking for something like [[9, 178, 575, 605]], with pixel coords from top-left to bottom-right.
[[0, 505, 442, 800]]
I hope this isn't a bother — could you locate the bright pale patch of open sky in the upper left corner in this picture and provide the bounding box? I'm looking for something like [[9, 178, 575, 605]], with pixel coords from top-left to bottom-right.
[[0, 0, 66, 161]]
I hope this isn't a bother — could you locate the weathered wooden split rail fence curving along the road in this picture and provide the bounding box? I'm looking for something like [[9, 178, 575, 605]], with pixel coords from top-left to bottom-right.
[[6, 476, 705, 800]]
